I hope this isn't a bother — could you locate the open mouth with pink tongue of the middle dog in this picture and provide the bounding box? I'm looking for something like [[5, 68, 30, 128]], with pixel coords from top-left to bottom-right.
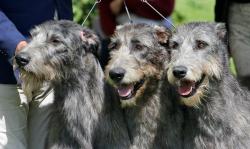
[[117, 80, 144, 100]]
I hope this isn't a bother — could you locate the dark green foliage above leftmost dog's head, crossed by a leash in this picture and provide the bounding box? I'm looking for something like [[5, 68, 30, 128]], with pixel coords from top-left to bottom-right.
[[72, 0, 98, 27]]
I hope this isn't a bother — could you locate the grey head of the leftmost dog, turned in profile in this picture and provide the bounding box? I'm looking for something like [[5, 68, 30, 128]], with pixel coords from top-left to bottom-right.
[[15, 20, 100, 81]]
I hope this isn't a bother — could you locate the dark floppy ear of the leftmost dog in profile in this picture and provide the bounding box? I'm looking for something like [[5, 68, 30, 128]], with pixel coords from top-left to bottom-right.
[[80, 30, 101, 56]]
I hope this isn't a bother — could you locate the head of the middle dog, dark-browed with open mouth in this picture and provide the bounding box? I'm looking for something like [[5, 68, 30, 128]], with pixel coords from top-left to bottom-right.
[[105, 24, 170, 107]]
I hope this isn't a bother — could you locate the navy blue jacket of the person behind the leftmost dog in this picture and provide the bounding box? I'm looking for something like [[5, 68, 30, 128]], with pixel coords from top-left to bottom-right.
[[0, 0, 73, 84]]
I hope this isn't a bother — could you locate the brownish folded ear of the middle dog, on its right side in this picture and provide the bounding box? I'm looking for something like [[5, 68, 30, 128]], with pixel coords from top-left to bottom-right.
[[154, 25, 172, 45]]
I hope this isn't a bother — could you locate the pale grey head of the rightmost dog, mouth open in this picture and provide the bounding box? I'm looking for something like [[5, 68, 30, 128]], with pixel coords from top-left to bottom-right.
[[167, 22, 228, 107]]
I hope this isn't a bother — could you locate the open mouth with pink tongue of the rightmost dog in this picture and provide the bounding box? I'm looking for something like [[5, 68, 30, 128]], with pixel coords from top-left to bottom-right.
[[178, 74, 205, 98]]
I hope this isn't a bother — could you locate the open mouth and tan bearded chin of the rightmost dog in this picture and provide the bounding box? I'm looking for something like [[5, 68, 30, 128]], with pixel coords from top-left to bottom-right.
[[177, 75, 209, 107]]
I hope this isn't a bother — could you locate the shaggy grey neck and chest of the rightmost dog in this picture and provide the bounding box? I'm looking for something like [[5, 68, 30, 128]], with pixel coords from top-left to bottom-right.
[[184, 74, 250, 148]]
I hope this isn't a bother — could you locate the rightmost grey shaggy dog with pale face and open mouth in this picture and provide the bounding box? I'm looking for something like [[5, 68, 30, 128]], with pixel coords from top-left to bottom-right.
[[168, 22, 250, 149]]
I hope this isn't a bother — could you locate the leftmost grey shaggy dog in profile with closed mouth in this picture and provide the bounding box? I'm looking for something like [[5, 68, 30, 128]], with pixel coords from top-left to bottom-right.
[[15, 21, 130, 149]]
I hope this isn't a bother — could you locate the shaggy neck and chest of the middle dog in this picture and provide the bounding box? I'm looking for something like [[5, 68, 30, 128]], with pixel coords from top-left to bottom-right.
[[125, 79, 182, 149]]
